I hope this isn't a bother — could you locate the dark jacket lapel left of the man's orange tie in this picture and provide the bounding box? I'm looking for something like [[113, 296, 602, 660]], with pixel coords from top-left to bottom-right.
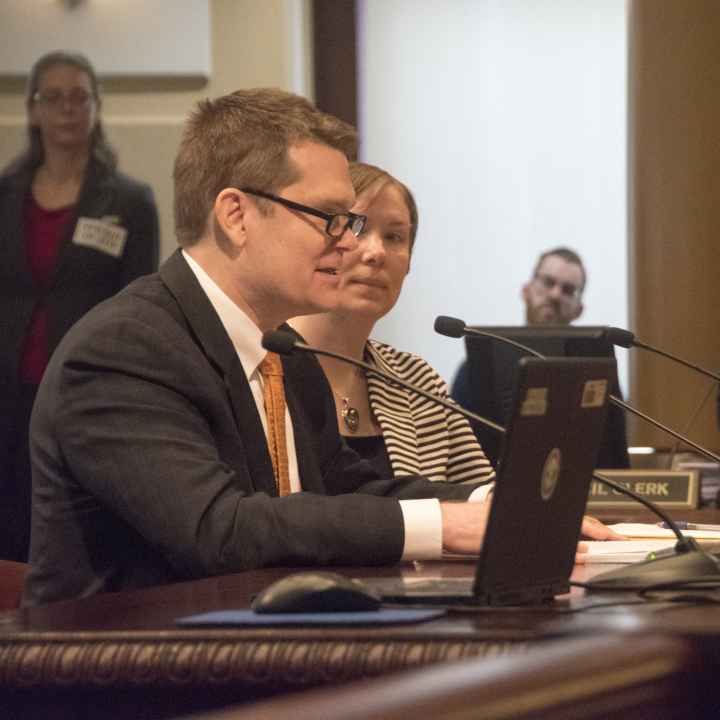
[[160, 250, 277, 495]]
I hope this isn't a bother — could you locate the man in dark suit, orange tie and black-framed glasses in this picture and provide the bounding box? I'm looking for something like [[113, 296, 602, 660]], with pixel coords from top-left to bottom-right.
[[24, 90, 496, 605]]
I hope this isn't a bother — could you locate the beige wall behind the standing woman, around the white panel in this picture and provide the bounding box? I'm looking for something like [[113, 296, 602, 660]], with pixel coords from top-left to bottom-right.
[[0, 0, 312, 259]]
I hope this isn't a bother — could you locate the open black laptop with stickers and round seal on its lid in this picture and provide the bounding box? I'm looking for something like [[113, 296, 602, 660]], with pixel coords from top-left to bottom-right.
[[364, 358, 616, 605]]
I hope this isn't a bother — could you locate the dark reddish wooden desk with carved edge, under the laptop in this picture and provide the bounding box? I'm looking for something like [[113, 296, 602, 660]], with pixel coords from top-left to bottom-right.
[[0, 562, 720, 718]]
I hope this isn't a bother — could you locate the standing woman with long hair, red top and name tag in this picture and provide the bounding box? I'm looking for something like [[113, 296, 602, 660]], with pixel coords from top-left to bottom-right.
[[0, 51, 158, 561]]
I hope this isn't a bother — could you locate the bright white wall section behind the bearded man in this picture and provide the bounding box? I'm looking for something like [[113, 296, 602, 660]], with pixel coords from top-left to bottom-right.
[[359, 0, 628, 388]]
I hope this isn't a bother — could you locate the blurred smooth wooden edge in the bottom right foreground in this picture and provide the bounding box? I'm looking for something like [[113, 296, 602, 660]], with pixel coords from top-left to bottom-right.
[[188, 635, 701, 720]]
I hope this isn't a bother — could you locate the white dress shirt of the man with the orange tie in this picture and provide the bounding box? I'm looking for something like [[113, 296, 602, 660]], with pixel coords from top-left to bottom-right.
[[183, 251, 491, 560]]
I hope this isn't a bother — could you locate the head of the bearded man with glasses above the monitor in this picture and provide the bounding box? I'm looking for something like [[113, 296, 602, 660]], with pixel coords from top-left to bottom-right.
[[522, 247, 586, 325]]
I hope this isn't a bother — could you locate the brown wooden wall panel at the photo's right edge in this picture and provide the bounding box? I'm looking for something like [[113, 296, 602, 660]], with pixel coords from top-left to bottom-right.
[[628, 0, 720, 450]]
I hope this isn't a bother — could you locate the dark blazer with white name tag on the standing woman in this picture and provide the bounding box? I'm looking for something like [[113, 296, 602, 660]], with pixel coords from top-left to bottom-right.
[[0, 162, 158, 457]]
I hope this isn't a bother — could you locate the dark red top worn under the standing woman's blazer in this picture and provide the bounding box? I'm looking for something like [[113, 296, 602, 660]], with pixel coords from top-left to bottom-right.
[[20, 192, 75, 385]]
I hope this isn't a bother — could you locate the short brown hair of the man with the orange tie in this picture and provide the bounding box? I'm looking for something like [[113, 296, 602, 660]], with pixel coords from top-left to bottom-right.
[[173, 88, 357, 247]]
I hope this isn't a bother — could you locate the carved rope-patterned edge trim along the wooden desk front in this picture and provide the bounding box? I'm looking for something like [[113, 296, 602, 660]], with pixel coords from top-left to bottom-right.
[[0, 632, 528, 692]]
